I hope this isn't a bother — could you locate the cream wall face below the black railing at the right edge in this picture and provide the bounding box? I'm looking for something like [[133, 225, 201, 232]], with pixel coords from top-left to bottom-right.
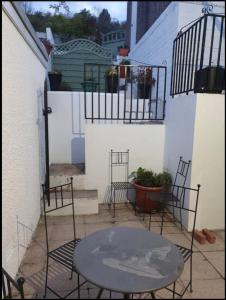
[[191, 94, 225, 229]]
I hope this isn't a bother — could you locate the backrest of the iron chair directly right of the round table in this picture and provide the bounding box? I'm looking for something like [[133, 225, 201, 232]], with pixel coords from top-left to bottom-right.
[[165, 184, 200, 250]]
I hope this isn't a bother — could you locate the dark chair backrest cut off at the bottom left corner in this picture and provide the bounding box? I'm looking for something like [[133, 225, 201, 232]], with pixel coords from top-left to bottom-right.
[[2, 268, 25, 299]]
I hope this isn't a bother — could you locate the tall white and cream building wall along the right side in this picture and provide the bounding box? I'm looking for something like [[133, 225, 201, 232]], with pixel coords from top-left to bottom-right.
[[129, 1, 225, 229]]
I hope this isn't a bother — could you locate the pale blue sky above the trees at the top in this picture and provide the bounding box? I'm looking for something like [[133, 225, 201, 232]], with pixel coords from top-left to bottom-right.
[[29, 1, 127, 22]]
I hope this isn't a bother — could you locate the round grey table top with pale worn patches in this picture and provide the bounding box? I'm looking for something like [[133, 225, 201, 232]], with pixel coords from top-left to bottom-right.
[[74, 227, 184, 294]]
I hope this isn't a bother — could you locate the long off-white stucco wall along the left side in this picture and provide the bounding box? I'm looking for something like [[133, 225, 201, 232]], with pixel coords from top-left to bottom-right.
[[2, 11, 45, 276]]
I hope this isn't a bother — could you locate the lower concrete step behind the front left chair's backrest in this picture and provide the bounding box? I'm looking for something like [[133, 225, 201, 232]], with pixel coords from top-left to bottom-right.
[[42, 190, 99, 216]]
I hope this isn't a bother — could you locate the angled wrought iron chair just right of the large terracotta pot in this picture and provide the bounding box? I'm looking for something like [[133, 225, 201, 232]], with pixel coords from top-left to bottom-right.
[[149, 156, 191, 234]]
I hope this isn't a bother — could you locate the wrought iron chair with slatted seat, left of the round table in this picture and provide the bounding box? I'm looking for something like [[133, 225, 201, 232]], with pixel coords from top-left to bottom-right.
[[42, 177, 86, 298]]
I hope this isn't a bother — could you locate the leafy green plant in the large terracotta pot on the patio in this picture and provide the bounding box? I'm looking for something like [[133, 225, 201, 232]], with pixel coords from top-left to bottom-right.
[[130, 167, 172, 187]]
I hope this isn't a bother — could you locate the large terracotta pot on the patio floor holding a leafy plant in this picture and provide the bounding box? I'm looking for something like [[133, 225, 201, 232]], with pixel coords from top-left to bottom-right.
[[132, 182, 163, 212]]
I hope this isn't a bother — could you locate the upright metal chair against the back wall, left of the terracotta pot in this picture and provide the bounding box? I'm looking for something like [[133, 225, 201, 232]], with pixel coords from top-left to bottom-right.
[[109, 150, 131, 218]]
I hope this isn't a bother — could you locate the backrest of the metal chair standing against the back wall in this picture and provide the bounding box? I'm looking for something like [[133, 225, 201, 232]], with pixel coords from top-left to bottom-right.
[[110, 149, 129, 183]]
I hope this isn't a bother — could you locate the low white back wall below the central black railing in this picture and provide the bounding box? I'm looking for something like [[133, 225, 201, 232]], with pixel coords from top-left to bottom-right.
[[85, 124, 165, 202]]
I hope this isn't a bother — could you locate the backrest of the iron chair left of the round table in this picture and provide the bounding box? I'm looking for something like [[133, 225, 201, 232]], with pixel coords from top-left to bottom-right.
[[42, 177, 76, 253]]
